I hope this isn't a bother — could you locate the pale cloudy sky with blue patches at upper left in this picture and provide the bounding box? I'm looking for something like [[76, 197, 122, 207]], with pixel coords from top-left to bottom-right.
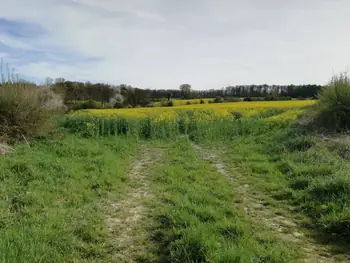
[[0, 0, 350, 89]]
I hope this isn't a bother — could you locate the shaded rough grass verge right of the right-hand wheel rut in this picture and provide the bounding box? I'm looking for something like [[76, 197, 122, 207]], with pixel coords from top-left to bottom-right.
[[206, 121, 350, 245]]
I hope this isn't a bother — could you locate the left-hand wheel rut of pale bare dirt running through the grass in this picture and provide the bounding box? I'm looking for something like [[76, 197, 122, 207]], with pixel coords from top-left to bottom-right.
[[106, 145, 162, 263]]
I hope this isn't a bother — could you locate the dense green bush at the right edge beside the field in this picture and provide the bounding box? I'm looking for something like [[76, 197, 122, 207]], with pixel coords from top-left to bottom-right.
[[313, 73, 350, 132]]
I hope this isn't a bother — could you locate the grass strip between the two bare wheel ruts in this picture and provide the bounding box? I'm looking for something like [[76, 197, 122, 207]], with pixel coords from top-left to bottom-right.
[[148, 139, 297, 263]]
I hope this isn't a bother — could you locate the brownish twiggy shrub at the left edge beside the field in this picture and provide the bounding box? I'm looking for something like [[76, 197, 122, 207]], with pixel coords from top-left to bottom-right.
[[0, 62, 62, 140]]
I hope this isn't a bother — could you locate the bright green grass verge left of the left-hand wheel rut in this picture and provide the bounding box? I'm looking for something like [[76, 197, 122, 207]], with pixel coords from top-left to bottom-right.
[[0, 135, 136, 262]]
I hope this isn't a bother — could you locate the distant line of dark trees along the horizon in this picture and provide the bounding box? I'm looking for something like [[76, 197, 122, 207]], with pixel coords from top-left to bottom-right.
[[45, 78, 322, 107]]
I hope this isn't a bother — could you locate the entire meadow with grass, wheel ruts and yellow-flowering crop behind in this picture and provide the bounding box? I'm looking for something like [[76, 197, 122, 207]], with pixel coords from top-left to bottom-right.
[[0, 97, 350, 263]]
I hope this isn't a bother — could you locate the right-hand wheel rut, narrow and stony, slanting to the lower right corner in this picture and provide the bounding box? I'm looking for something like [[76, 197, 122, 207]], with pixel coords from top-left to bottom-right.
[[192, 143, 350, 263]]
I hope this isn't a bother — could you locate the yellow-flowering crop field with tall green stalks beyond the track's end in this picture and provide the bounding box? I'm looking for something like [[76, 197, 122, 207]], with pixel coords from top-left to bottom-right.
[[64, 100, 315, 138]]
